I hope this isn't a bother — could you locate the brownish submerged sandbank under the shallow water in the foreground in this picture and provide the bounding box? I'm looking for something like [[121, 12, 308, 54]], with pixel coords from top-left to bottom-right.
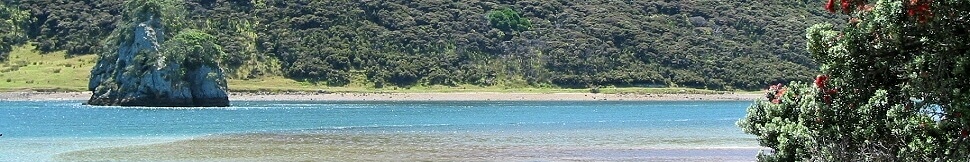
[[56, 133, 758, 161]]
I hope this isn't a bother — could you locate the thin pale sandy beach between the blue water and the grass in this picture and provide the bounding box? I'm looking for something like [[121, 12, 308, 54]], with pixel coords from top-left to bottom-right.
[[0, 92, 762, 101]]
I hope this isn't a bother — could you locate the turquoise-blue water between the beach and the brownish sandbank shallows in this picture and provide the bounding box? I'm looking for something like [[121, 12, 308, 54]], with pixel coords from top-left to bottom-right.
[[0, 101, 757, 161]]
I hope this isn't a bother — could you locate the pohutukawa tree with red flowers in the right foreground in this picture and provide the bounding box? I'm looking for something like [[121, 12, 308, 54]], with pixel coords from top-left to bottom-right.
[[738, 0, 970, 161]]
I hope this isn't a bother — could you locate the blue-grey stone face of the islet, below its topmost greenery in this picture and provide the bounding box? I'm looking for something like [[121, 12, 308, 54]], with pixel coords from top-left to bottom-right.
[[87, 18, 229, 107]]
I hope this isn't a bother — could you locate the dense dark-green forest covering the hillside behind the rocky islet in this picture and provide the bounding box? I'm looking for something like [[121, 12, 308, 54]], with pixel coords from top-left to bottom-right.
[[0, 0, 843, 90]]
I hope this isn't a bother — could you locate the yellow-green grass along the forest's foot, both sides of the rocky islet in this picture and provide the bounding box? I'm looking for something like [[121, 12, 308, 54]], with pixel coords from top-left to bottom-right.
[[0, 45, 748, 94]]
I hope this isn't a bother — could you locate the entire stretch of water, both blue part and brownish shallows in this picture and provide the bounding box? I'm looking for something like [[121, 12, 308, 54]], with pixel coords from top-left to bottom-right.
[[0, 101, 757, 161]]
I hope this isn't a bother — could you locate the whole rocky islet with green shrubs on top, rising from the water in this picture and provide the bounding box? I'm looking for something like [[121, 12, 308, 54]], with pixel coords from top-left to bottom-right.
[[87, 2, 229, 107]]
